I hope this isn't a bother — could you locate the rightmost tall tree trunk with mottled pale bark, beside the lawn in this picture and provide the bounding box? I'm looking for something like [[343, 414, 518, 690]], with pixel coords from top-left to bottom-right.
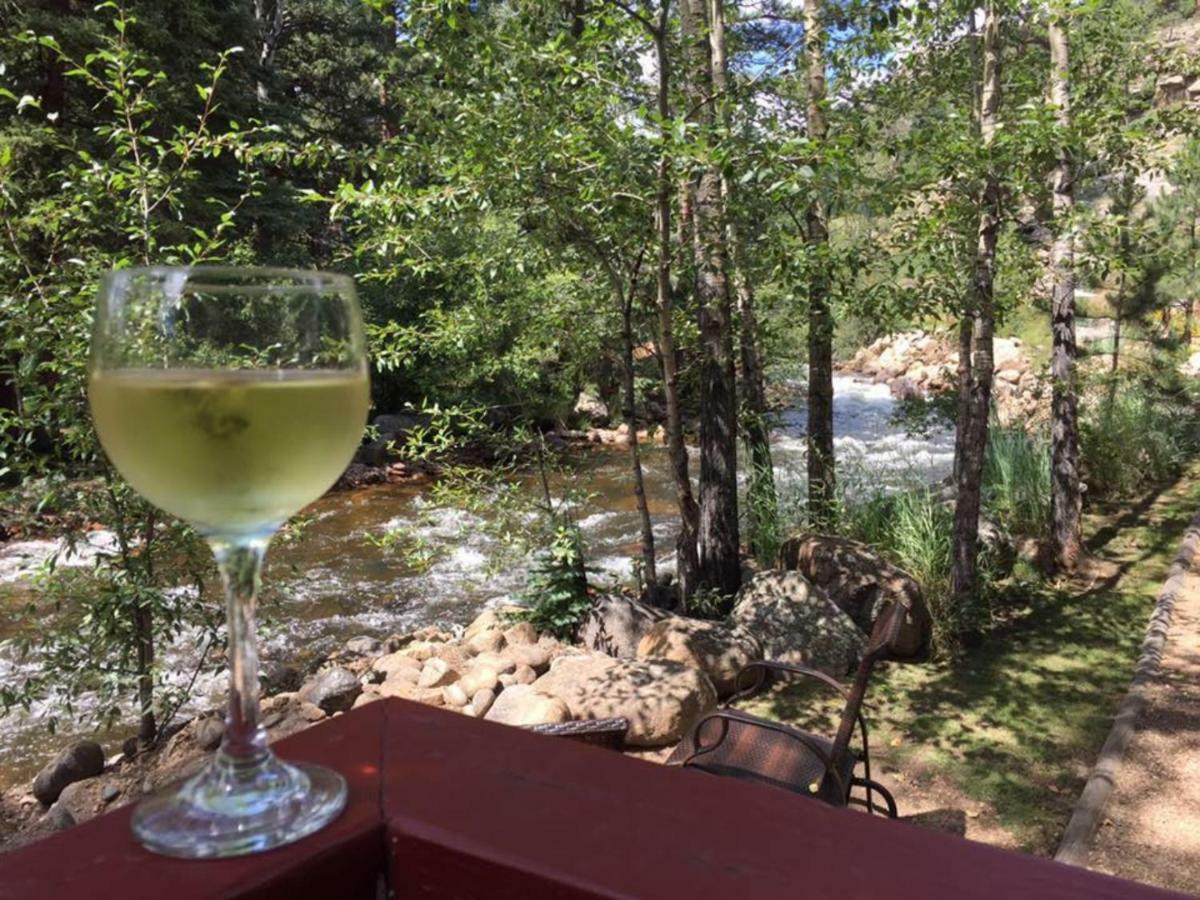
[[1049, 12, 1084, 572]]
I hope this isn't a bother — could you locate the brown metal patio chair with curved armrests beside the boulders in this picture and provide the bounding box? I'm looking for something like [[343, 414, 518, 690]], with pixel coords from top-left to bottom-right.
[[667, 588, 930, 818]]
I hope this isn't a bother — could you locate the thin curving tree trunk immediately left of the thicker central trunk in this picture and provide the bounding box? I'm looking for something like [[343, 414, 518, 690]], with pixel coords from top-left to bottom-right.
[[653, 12, 700, 611]]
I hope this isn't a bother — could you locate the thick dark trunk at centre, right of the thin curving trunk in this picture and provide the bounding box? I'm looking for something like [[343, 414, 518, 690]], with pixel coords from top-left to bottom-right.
[[680, 0, 742, 594]]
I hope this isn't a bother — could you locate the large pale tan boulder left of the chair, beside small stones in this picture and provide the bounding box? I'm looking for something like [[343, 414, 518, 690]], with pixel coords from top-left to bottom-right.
[[532, 654, 716, 746]]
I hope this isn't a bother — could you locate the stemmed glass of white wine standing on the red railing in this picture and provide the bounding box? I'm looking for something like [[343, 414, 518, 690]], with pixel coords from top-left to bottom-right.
[[88, 266, 368, 858]]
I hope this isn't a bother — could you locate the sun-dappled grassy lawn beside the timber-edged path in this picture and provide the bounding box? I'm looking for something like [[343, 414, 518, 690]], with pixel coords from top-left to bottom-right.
[[749, 467, 1200, 854]]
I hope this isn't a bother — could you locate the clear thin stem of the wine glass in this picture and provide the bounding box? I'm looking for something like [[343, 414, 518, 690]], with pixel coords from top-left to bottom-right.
[[209, 538, 270, 764]]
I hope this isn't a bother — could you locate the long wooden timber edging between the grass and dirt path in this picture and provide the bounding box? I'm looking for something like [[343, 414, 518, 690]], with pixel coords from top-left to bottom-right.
[[1054, 512, 1200, 866]]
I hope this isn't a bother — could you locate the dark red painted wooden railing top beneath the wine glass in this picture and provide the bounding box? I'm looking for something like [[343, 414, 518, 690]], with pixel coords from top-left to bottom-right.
[[0, 700, 1175, 900]]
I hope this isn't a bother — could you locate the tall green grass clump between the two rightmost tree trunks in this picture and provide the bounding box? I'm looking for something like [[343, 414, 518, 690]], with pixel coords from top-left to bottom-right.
[[983, 425, 1051, 538]]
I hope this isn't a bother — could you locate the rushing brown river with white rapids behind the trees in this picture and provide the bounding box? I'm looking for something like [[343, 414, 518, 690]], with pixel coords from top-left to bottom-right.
[[0, 377, 954, 788]]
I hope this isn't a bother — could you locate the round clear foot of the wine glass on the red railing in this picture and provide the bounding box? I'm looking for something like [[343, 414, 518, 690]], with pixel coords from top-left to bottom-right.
[[133, 754, 346, 859]]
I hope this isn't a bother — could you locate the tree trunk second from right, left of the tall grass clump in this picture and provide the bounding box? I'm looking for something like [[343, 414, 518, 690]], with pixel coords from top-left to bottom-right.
[[953, 1, 1000, 611]]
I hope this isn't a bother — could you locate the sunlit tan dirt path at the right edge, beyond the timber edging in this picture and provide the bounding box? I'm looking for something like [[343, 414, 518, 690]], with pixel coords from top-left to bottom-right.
[[1088, 570, 1200, 894]]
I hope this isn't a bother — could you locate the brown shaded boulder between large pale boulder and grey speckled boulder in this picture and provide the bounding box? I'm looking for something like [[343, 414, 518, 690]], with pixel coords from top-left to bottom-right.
[[637, 616, 762, 697]]
